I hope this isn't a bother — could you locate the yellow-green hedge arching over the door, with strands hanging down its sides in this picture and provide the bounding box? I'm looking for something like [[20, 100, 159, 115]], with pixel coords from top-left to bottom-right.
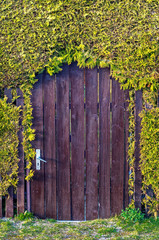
[[0, 0, 159, 214]]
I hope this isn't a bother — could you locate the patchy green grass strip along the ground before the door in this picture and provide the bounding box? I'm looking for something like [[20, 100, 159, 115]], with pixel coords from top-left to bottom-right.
[[0, 216, 159, 240]]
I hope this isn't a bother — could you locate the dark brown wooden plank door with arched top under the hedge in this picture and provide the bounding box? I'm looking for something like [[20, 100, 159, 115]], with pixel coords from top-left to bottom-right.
[[31, 63, 128, 220]]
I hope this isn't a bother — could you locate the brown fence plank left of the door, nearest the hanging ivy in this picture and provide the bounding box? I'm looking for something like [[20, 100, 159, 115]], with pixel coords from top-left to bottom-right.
[[16, 89, 25, 214]]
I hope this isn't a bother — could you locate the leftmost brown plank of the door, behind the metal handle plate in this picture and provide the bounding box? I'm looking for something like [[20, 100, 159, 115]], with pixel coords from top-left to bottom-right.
[[31, 74, 45, 218]]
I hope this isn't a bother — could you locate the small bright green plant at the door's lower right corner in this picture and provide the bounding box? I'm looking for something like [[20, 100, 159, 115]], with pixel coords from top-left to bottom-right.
[[121, 207, 144, 223]]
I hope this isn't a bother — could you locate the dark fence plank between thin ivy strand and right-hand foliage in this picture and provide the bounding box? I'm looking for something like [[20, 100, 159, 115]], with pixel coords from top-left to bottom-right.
[[134, 90, 142, 210]]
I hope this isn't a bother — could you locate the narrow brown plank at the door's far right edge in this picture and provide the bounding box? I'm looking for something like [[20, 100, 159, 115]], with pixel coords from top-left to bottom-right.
[[124, 90, 129, 208]]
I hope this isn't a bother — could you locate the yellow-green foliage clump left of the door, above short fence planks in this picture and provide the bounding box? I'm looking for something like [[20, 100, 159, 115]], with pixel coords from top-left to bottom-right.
[[0, 98, 20, 195]]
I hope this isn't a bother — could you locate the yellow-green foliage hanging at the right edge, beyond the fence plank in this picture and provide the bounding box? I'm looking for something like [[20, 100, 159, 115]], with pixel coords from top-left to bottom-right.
[[141, 101, 159, 213]]
